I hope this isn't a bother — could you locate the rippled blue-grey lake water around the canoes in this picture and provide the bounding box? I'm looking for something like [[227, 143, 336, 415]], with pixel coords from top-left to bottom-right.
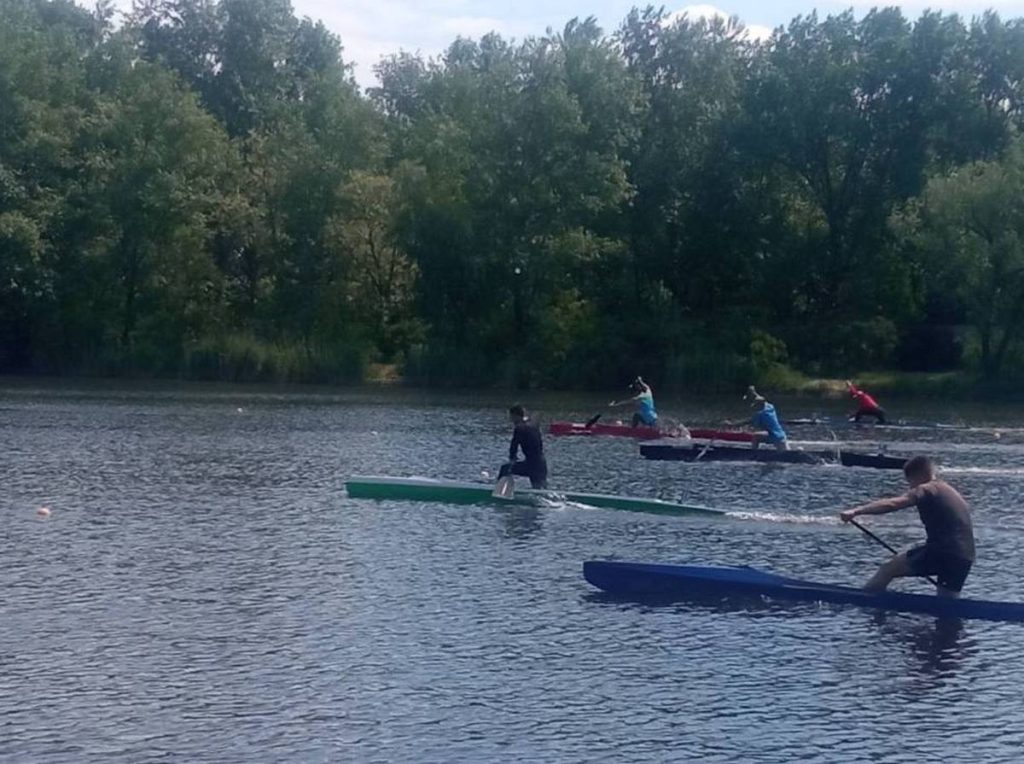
[[0, 383, 1024, 762]]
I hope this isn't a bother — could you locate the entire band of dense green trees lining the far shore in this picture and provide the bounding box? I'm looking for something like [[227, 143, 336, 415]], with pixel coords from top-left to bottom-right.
[[6, 0, 1024, 389]]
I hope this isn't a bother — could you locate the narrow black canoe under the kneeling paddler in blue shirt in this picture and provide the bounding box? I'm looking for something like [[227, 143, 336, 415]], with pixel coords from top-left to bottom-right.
[[640, 438, 907, 469]]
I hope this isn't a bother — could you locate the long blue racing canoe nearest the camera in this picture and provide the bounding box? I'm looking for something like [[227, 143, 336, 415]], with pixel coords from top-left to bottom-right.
[[583, 560, 1024, 622]]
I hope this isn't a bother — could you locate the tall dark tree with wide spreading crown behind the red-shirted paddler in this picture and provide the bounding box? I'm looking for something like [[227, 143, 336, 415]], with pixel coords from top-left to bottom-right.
[[744, 9, 1011, 367]]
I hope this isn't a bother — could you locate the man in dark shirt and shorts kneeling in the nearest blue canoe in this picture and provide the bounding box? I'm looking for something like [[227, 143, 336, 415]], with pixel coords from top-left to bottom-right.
[[840, 457, 974, 597]]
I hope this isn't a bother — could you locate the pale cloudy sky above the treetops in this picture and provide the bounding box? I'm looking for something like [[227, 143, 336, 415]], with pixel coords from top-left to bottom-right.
[[108, 0, 1024, 87]]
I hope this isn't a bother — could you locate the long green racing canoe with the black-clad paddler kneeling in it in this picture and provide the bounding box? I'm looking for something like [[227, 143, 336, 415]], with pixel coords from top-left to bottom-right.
[[345, 475, 725, 515]]
